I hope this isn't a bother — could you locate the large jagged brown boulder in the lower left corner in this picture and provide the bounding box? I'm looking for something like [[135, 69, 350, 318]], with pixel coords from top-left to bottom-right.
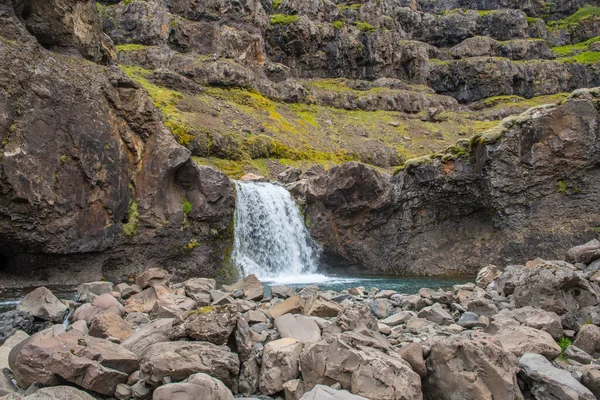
[[9, 330, 138, 396]]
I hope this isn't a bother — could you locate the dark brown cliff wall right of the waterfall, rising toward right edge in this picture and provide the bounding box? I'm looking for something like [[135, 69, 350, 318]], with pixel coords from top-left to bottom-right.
[[292, 89, 600, 274]]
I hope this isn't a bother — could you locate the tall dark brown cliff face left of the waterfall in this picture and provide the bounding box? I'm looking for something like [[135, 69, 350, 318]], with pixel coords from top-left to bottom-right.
[[0, 1, 234, 285]]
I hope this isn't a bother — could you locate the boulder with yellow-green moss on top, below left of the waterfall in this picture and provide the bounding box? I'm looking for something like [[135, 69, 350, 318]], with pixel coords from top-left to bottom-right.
[[183, 306, 237, 345]]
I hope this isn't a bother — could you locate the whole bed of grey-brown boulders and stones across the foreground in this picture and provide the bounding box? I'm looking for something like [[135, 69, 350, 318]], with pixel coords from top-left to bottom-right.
[[0, 240, 600, 400]]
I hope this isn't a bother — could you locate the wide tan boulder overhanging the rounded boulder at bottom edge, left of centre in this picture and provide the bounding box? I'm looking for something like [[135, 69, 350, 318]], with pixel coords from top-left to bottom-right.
[[140, 342, 240, 387]]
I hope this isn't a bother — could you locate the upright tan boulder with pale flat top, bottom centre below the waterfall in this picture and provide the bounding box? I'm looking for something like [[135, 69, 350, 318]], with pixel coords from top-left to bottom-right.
[[258, 338, 304, 395]]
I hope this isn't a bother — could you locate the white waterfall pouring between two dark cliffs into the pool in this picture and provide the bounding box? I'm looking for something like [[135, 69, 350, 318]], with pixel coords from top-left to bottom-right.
[[232, 181, 325, 282]]
